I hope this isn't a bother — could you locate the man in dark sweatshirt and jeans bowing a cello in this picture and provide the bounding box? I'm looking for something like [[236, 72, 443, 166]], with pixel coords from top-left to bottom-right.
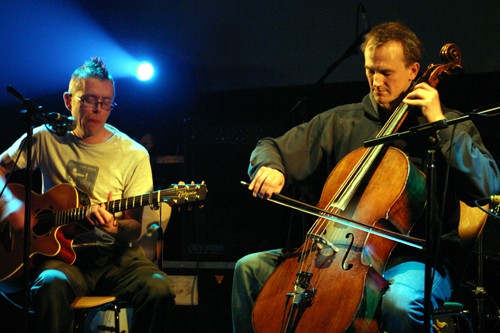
[[232, 22, 500, 333]]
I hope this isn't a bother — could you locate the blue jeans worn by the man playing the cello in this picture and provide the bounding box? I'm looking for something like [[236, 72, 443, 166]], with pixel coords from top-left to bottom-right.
[[231, 249, 452, 333]]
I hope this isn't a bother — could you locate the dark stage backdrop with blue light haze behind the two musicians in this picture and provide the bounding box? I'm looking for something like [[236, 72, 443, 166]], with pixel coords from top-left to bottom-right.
[[0, 0, 500, 332]]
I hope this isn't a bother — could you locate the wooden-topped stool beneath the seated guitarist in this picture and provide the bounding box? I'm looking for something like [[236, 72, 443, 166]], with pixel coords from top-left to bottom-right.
[[71, 296, 121, 333]]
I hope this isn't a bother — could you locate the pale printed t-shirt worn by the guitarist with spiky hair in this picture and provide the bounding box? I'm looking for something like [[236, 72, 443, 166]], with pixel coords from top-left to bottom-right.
[[8, 124, 153, 203]]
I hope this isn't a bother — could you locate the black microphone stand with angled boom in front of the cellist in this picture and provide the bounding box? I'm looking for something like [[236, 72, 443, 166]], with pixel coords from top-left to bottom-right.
[[364, 106, 500, 332]]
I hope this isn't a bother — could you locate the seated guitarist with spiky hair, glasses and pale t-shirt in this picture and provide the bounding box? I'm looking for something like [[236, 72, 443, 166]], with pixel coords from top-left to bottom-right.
[[0, 58, 175, 333]]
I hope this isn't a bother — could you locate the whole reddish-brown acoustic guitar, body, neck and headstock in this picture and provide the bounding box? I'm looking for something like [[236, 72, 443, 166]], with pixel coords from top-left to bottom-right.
[[0, 183, 207, 292]]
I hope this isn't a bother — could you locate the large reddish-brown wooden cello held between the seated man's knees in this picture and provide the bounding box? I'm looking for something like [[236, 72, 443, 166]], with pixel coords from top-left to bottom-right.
[[252, 43, 461, 333]]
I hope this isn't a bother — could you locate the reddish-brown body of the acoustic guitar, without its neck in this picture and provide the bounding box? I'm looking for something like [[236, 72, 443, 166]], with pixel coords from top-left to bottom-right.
[[0, 184, 79, 292]]
